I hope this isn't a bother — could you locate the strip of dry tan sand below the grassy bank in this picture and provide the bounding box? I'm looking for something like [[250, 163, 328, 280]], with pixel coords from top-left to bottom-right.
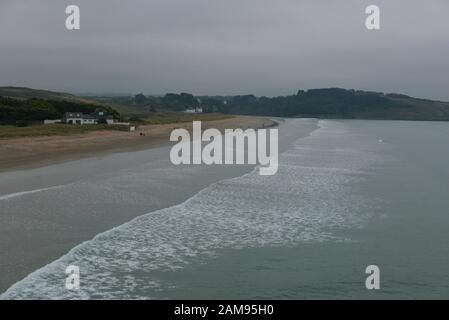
[[0, 116, 273, 171]]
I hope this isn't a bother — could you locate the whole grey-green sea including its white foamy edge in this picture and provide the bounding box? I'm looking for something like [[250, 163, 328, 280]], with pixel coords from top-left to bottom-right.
[[0, 120, 449, 299]]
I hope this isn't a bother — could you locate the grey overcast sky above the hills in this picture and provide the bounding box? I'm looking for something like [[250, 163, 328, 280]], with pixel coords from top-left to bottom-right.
[[0, 0, 449, 100]]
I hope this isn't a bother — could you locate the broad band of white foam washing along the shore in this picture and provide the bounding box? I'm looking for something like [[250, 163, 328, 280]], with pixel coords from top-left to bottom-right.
[[0, 121, 383, 299]]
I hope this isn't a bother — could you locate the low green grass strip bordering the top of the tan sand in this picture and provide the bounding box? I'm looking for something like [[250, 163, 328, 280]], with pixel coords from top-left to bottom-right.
[[0, 112, 232, 139]]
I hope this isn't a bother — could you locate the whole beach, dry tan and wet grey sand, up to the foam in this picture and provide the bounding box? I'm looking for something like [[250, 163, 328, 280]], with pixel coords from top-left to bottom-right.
[[0, 116, 300, 293]]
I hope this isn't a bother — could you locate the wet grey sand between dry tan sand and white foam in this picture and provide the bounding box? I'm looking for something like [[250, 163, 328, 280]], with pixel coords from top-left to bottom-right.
[[0, 120, 319, 296]]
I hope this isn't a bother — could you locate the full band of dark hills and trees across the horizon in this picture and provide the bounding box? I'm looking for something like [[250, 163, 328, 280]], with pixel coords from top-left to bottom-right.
[[0, 87, 449, 123]]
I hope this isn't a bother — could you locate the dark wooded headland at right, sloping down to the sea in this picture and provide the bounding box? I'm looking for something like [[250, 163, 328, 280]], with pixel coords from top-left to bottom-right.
[[220, 88, 449, 121]]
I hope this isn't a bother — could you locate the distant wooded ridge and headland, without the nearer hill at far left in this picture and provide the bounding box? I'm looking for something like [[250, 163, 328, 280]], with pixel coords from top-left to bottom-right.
[[90, 88, 449, 121]]
